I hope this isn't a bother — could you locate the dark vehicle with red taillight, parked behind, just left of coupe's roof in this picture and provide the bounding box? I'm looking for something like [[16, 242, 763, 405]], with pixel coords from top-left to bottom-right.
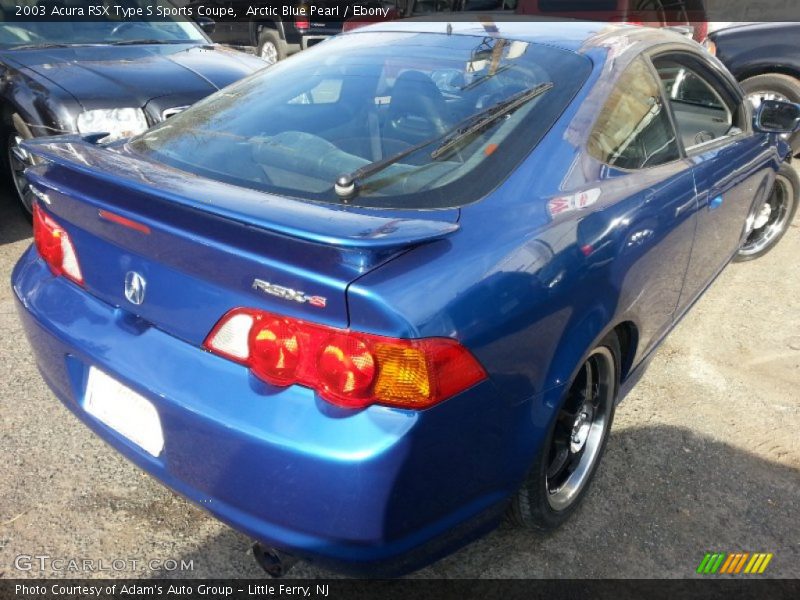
[[187, 0, 354, 65]]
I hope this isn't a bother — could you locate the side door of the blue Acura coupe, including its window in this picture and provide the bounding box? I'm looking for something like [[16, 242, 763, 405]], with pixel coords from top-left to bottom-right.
[[653, 52, 771, 307]]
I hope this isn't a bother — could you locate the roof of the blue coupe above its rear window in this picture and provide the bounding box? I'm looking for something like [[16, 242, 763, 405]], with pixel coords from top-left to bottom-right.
[[344, 14, 699, 52]]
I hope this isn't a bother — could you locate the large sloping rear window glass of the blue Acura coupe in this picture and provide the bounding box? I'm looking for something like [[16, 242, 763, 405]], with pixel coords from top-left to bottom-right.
[[131, 32, 591, 209]]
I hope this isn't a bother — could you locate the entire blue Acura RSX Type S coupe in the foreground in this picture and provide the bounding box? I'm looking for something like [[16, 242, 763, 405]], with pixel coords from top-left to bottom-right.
[[13, 22, 800, 575]]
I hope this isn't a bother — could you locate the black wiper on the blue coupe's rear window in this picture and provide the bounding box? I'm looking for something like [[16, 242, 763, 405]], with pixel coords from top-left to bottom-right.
[[334, 82, 553, 199]]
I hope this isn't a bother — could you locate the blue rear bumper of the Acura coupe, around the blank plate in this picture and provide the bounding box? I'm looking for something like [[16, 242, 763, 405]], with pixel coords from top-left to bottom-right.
[[12, 248, 531, 575]]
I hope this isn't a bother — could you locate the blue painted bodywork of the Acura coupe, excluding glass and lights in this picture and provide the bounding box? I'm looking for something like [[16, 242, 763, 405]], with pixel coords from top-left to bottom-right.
[[13, 24, 787, 573]]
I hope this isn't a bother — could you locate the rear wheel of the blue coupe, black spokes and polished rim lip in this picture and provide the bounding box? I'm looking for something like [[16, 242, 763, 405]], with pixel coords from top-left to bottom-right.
[[508, 333, 620, 531]]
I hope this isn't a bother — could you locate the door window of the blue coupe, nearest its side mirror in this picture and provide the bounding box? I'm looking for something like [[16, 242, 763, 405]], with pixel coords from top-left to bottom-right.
[[653, 58, 741, 152]]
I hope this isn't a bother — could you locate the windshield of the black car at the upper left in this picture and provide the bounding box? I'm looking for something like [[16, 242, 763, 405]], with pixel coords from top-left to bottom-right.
[[0, 0, 207, 49]]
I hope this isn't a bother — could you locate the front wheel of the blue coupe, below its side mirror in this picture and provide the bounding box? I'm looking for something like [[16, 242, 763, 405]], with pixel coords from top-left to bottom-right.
[[734, 163, 800, 262]]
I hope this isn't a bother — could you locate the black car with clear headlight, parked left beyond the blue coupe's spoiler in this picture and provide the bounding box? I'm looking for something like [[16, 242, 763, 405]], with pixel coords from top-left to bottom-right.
[[0, 0, 264, 218]]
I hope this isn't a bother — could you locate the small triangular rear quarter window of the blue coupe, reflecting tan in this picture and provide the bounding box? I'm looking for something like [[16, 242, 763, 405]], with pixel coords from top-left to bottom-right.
[[588, 58, 680, 169]]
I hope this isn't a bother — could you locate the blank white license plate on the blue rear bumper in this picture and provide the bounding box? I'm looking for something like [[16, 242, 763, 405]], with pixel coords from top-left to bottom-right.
[[83, 367, 164, 456]]
